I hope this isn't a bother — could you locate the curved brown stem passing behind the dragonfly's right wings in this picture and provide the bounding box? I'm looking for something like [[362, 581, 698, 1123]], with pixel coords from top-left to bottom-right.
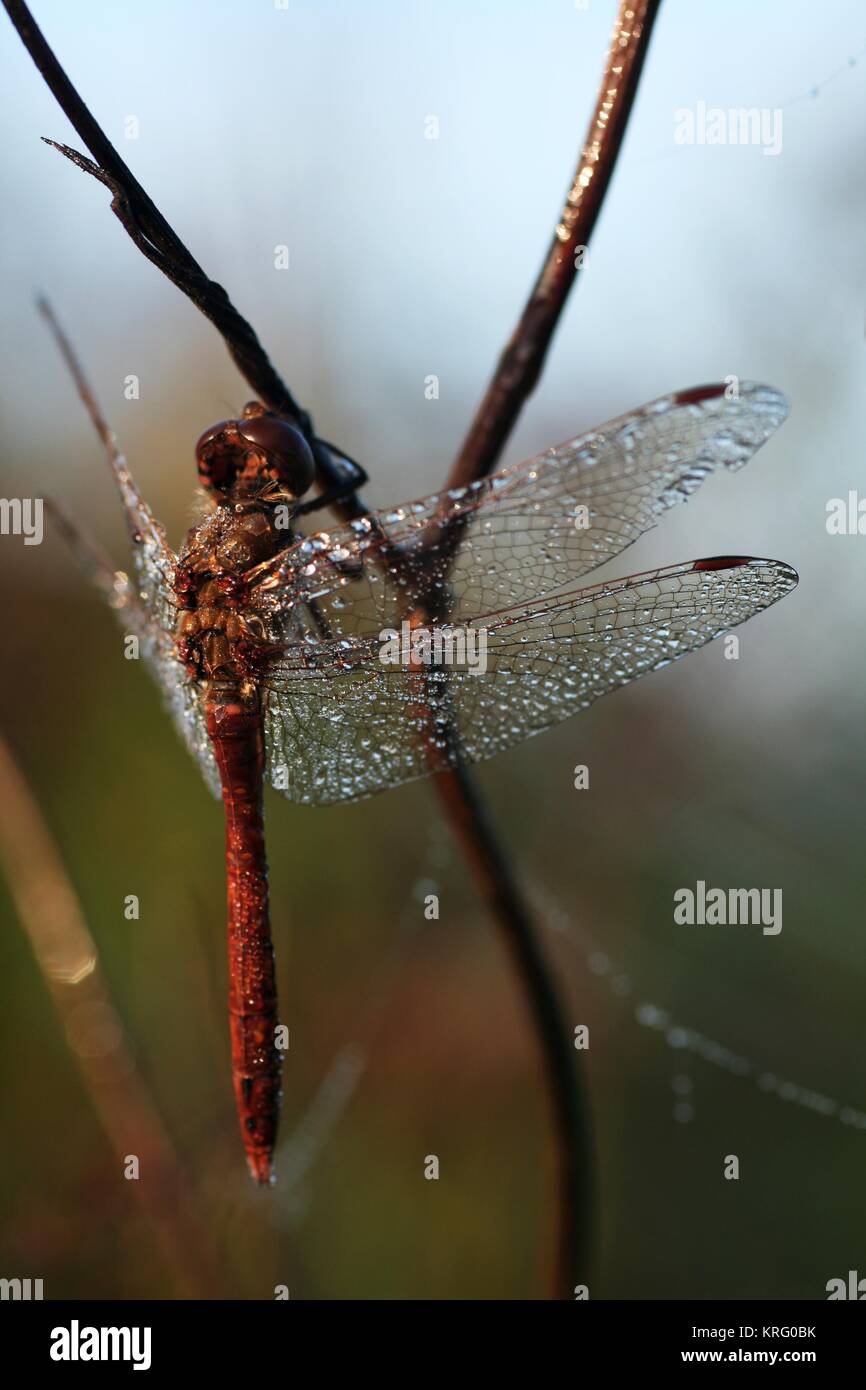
[[436, 0, 660, 1298]]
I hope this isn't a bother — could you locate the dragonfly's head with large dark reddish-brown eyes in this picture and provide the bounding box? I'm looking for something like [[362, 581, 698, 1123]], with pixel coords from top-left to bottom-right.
[[196, 400, 316, 498]]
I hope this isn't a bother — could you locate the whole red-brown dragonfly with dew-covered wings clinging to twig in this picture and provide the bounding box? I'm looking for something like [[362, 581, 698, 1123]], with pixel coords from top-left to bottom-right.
[[42, 315, 798, 1184]]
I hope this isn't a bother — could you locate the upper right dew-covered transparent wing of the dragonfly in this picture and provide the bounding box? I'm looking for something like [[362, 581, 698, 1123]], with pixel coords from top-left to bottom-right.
[[253, 382, 788, 637]]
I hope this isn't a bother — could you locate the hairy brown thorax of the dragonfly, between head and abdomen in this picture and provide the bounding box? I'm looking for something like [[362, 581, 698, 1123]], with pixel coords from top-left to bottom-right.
[[175, 502, 289, 684]]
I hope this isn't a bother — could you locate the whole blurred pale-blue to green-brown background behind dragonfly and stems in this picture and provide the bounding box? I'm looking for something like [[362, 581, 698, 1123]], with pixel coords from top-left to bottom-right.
[[0, 0, 866, 1298]]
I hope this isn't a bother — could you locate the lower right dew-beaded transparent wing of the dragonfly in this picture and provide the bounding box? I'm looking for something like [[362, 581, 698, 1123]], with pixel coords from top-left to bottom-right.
[[263, 547, 796, 805]]
